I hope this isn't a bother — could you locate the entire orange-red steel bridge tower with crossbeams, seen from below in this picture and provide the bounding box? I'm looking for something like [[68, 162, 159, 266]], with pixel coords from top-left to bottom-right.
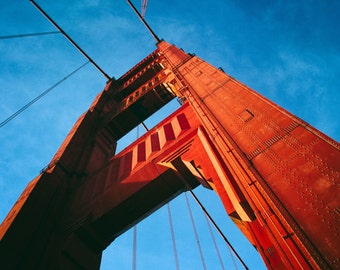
[[0, 41, 340, 269]]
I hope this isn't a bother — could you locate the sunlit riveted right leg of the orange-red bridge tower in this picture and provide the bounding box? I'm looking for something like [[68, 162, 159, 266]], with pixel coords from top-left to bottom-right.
[[159, 43, 340, 269]]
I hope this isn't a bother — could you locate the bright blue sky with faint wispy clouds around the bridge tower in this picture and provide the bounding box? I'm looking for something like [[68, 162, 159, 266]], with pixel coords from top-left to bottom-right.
[[0, 0, 340, 269]]
